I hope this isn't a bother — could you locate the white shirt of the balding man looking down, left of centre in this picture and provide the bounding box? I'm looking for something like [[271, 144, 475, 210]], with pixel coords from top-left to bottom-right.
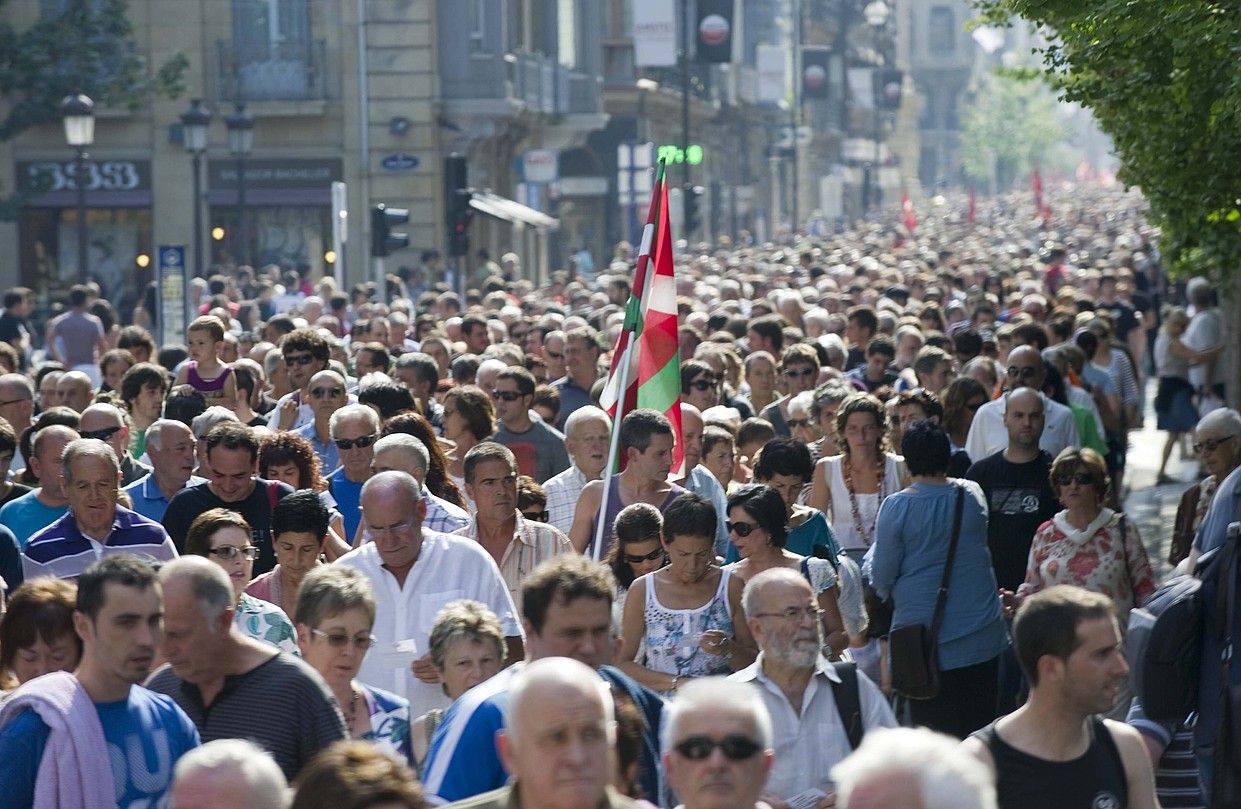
[[336, 530, 521, 716]]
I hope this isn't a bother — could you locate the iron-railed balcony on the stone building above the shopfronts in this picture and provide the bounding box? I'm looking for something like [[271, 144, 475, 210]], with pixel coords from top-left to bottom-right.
[[216, 40, 328, 102]]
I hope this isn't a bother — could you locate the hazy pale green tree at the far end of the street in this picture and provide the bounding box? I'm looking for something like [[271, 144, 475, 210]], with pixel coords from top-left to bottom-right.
[[961, 69, 1065, 191]]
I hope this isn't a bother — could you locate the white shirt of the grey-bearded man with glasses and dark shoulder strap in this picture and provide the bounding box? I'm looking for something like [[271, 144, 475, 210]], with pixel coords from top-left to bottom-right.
[[728, 653, 896, 800]]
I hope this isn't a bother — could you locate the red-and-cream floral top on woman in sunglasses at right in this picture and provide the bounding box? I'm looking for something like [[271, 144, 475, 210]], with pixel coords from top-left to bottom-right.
[[1018, 509, 1155, 612]]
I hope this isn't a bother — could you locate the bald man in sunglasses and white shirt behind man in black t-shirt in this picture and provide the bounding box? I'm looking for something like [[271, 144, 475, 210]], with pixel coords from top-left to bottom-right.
[[965, 345, 1081, 460]]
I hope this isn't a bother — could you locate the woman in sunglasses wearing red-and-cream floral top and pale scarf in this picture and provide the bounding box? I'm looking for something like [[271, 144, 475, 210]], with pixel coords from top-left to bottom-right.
[[1000, 447, 1155, 627]]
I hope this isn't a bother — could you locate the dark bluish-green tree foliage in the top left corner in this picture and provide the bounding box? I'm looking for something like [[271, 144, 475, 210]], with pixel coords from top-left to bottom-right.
[[0, 0, 189, 140]]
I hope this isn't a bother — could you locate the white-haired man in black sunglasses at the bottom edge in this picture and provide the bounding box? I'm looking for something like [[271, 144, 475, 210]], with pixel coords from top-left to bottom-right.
[[664, 677, 769, 809]]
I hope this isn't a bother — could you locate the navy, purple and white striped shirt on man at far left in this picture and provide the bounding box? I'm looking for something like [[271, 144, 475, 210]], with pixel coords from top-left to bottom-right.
[[21, 505, 177, 579]]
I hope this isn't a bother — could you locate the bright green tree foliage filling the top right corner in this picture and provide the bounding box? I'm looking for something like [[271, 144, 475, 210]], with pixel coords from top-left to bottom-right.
[[978, 0, 1241, 279]]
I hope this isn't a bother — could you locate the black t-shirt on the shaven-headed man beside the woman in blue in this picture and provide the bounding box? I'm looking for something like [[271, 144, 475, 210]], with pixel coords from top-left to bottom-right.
[[965, 450, 1060, 591]]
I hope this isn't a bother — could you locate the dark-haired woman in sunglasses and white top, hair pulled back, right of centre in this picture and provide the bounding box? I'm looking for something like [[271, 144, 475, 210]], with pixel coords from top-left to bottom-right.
[[725, 483, 849, 656]]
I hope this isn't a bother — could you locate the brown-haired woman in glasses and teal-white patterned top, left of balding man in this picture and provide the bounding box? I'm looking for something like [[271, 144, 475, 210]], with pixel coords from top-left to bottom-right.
[[185, 509, 298, 655]]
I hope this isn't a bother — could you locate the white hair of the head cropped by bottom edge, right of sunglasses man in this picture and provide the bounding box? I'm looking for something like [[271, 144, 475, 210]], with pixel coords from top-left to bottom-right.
[[831, 727, 998, 809]]
